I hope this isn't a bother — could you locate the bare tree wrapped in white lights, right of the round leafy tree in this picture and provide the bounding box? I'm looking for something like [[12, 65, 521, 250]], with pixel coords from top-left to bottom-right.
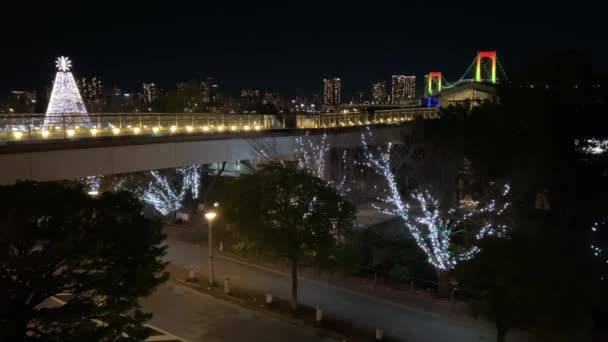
[[361, 127, 510, 270]]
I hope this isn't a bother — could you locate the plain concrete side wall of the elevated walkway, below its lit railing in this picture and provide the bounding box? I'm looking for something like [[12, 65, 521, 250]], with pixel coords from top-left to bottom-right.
[[0, 125, 410, 184]]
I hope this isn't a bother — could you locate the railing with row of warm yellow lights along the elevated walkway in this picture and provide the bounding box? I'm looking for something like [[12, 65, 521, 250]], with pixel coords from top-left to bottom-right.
[[0, 108, 438, 143]]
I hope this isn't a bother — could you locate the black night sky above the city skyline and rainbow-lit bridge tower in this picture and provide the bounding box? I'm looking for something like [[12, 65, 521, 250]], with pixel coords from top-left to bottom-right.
[[0, 1, 608, 95]]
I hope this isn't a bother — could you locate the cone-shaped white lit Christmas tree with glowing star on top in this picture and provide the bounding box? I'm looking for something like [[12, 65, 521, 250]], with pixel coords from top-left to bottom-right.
[[44, 56, 91, 127]]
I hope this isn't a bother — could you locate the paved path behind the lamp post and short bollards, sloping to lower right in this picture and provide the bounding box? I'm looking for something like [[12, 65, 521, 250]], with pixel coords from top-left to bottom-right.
[[166, 240, 529, 342]]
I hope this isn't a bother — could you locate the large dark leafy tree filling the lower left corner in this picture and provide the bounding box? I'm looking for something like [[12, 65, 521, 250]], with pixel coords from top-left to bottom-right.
[[0, 182, 167, 341]]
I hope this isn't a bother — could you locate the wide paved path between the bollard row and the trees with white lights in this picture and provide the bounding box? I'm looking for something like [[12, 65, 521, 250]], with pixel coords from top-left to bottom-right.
[[164, 240, 530, 342]]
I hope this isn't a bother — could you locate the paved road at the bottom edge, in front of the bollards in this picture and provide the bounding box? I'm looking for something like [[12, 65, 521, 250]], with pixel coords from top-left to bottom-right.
[[141, 284, 329, 342]]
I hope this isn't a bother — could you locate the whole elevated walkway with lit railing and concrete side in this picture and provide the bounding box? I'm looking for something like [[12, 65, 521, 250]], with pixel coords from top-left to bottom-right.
[[0, 108, 438, 184]]
